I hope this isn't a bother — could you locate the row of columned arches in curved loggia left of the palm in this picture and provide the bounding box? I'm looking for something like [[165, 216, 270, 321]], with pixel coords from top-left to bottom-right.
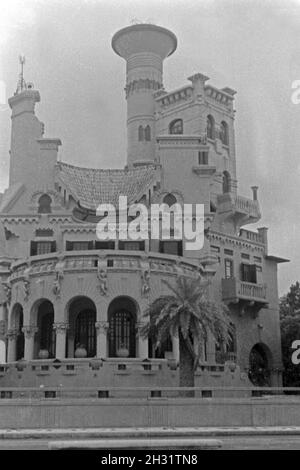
[[7, 296, 158, 362]]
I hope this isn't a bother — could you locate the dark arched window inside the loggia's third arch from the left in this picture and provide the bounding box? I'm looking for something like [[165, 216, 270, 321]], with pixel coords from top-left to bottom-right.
[[74, 310, 96, 357]]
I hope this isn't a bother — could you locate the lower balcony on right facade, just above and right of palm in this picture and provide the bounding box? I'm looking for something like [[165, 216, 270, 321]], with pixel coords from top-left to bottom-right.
[[222, 277, 268, 308]]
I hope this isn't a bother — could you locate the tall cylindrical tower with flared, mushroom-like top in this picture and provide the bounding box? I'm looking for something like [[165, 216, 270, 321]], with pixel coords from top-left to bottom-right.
[[112, 24, 177, 166]]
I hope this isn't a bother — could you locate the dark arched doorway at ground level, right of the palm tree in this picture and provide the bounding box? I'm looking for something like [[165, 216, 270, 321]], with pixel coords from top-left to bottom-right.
[[248, 343, 271, 387]]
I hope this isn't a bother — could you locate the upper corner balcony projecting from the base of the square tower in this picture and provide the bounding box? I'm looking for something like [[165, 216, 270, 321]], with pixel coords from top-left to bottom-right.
[[218, 193, 261, 226]]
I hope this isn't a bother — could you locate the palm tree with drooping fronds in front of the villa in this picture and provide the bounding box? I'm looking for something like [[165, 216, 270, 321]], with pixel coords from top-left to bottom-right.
[[142, 276, 232, 396]]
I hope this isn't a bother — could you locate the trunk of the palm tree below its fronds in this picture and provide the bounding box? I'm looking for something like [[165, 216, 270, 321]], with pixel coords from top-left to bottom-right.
[[178, 330, 195, 397]]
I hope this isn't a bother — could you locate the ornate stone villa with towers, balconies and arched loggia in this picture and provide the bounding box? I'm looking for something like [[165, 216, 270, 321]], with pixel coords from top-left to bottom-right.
[[0, 24, 285, 384]]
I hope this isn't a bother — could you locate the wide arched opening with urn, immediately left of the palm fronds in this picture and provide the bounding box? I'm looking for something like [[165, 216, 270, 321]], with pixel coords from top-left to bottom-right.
[[108, 297, 137, 357]]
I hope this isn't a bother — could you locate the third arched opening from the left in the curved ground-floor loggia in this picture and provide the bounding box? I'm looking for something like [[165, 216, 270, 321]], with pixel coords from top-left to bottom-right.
[[67, 296, 97, 357]]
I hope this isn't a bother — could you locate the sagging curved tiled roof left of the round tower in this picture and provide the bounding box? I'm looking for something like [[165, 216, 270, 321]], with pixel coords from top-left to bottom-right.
[[57, 162, 157, 210]]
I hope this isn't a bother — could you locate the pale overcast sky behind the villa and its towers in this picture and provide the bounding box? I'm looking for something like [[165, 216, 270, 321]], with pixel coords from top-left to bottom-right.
[[0, 0, 300, 294]]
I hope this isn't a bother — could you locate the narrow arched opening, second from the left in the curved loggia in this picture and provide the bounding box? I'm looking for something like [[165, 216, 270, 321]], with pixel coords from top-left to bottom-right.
[[36, 300, 55, 358]]
